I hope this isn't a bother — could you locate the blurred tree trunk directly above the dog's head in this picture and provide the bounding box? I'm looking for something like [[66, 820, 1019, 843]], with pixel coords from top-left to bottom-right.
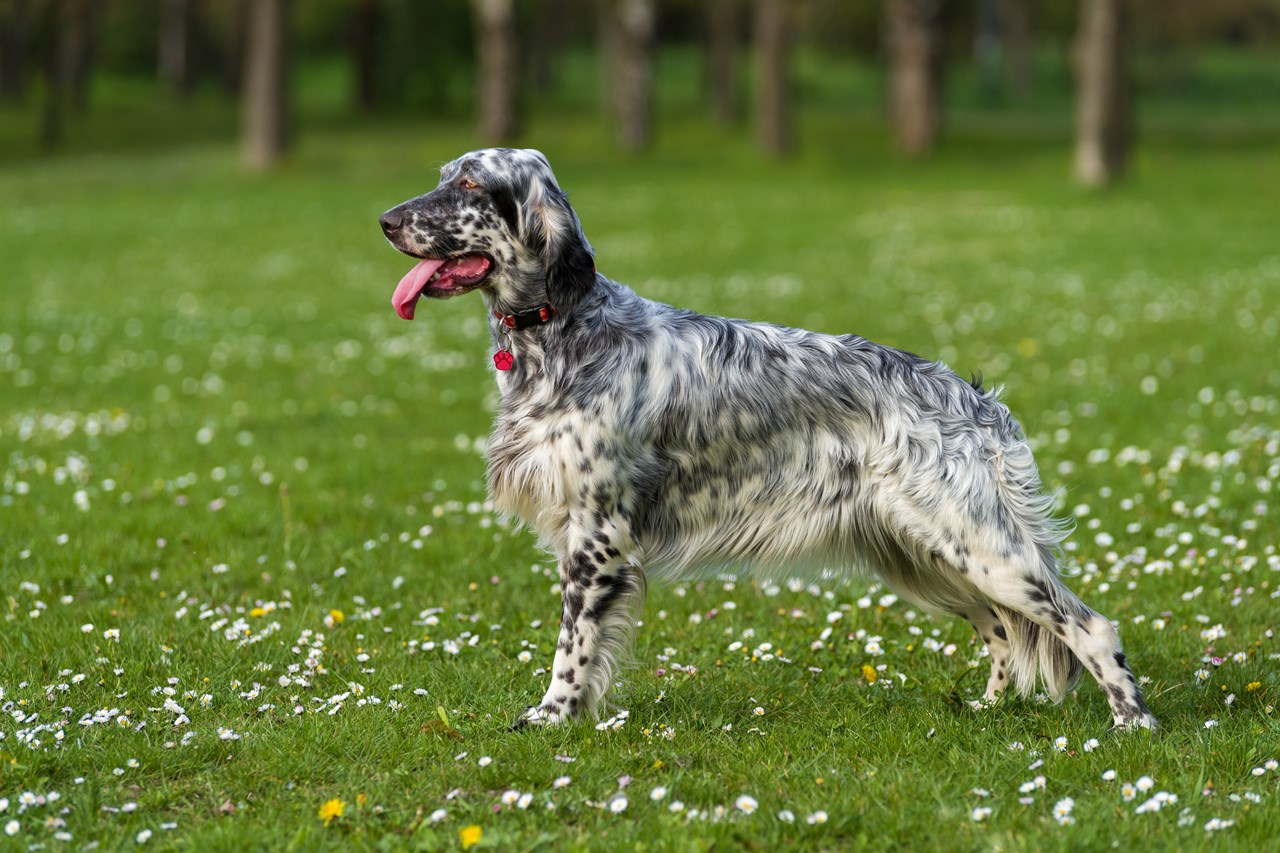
[[471, 0, 518, 142]]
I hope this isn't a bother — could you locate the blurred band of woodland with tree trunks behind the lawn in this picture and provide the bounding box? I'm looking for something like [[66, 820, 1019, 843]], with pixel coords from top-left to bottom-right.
[[0, 0, 1280, 184]]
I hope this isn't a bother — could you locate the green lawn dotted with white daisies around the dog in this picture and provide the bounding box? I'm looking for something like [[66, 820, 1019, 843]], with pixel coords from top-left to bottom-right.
[[0, 56, 1280, 850]]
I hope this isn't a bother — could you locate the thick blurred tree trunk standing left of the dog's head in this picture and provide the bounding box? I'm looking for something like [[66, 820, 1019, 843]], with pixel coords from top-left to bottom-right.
[[241, 0, 289, 170]]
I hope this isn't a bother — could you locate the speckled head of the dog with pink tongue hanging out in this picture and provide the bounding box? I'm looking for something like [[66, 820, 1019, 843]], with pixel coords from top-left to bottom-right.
[[379, 149, 595, 320]]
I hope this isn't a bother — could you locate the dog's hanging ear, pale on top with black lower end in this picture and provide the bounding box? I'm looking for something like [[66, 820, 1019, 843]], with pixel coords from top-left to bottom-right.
[[521, 174, 595, 307]]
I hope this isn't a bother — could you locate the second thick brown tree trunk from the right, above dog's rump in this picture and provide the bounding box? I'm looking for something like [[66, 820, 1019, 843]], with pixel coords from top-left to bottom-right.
[[886, 0, 942, 156]]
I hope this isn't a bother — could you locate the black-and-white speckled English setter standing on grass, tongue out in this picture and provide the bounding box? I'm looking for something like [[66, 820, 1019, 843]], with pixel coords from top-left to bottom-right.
[[380, 149, 1156, 729]]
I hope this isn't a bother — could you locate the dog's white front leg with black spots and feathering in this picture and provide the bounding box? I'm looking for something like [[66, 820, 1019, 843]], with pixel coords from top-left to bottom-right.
[[516, 532, 644, 729]]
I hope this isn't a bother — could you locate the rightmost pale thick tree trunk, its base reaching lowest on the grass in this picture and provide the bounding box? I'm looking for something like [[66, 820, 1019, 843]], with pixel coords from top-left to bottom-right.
[[1075, 0, 1130, 187]]
